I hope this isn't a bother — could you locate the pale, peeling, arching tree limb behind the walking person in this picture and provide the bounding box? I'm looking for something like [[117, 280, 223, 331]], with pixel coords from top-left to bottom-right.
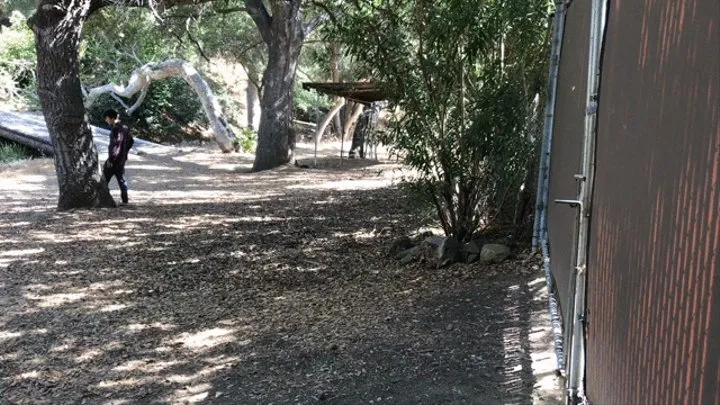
[[85, 59, 235, 152]]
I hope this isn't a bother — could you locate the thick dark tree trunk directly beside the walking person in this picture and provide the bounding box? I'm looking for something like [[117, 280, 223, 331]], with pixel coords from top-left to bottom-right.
[[29, 0, 115, 210]]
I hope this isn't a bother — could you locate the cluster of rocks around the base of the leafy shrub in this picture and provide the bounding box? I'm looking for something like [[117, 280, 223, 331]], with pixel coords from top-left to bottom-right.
[[389, 234, 510, 267]]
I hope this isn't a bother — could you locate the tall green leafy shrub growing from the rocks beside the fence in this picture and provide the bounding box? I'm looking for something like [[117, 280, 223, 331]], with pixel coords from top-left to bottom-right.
[[333, 0, 551, 240]]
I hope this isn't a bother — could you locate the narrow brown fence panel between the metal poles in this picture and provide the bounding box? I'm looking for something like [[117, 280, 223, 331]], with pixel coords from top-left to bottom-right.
[[548, 0, 591, 319]]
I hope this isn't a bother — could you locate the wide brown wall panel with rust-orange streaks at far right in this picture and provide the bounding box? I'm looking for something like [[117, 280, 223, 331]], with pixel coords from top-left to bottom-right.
[[584, 0, 720, 404]]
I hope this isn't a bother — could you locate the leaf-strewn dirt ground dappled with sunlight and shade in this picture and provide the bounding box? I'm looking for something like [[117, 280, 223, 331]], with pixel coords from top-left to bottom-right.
[[0, 149, 559, 404]]
